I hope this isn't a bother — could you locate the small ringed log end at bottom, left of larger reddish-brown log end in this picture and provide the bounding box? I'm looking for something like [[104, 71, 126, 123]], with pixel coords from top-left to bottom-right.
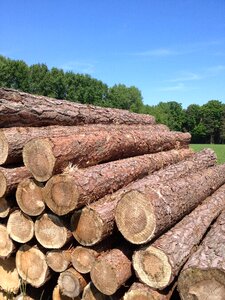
[[58, 268, 87, 298]]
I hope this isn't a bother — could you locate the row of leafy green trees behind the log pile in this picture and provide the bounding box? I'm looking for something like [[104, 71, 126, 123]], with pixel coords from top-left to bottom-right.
[[0, 56, 225, 143]]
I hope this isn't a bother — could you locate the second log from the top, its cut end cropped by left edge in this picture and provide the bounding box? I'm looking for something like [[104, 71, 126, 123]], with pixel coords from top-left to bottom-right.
[[0, 124, 166, 165]]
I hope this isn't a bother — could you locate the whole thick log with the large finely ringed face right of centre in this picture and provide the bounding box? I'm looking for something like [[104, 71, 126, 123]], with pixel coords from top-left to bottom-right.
[[115, 164, 225, 244]]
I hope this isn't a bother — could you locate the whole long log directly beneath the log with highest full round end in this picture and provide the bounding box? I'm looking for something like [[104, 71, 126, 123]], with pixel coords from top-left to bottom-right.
[[44, 149, 193, 215]]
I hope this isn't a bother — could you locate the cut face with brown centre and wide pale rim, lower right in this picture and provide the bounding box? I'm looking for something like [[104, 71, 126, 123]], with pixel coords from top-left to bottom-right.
[[133, 247, 172, 289]]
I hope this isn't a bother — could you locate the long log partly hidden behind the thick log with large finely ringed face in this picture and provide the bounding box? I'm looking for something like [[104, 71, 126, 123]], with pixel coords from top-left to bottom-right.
[[71, 149, 216, 246]]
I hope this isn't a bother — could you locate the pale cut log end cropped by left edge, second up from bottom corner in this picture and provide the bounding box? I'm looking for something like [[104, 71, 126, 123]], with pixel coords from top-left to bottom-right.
[[0, 224, 15, 258]]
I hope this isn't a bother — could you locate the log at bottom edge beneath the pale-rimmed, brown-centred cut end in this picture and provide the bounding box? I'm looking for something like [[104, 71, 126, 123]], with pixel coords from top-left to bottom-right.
[[123, 282, 176, 300]]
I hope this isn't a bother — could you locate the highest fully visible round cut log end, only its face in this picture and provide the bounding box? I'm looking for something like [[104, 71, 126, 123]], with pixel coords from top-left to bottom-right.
[[23, 138, 55, 182]]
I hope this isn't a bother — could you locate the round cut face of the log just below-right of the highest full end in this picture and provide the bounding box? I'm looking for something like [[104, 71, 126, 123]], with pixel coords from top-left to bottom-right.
[[44, 175, 79, 216]]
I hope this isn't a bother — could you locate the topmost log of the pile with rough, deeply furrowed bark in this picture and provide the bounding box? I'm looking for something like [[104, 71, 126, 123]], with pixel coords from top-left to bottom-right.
[[0, 88, 155, 127]]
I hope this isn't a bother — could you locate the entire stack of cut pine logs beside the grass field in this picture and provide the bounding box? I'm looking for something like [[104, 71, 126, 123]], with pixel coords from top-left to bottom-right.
[[0, 88, 225, 300]]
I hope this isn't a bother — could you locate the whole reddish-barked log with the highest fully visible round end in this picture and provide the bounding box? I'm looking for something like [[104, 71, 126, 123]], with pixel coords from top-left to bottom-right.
[[23, 130, 191, 181]]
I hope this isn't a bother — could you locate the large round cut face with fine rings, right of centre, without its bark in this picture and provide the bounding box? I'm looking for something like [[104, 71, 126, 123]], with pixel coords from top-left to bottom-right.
[[115, 191, 157, 244]]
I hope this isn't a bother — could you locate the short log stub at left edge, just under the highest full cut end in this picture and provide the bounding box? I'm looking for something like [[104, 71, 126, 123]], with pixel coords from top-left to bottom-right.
[[0, 167, 31, 198]]
